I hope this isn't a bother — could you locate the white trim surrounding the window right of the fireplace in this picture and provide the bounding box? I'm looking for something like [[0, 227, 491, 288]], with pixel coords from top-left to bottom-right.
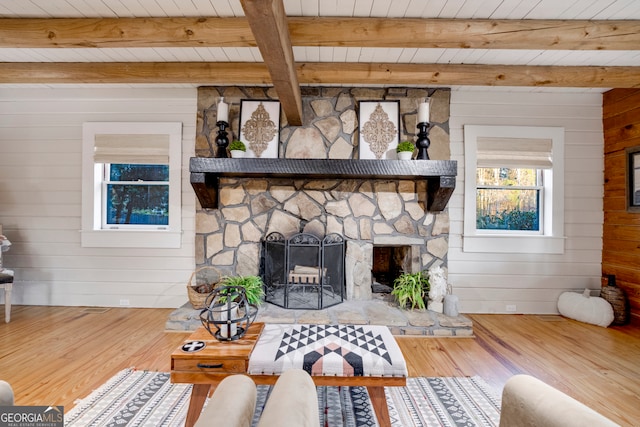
[[462, 125, 565, 254]]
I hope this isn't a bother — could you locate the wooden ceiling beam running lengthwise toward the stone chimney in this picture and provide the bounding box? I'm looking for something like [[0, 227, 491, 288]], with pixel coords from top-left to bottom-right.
[[240, 0, 302, 126]]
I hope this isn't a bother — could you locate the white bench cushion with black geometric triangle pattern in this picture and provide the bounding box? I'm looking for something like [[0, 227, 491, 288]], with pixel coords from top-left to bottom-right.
[[247, 324, 408, 378]]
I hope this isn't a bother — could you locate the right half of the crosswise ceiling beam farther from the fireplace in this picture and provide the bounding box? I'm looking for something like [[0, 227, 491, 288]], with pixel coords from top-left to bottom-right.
[[289, 17, 640, 50]]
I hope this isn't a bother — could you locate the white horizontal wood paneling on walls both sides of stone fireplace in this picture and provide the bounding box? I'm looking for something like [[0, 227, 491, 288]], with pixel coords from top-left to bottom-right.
[[0, 88, 603, 313]]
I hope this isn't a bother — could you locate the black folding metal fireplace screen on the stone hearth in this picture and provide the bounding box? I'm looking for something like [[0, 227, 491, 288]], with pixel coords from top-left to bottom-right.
[[263, 232, 344, 310]]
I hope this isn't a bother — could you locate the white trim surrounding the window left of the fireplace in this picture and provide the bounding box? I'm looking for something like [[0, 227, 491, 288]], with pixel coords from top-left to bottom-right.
[[81, 122, 182, 248]]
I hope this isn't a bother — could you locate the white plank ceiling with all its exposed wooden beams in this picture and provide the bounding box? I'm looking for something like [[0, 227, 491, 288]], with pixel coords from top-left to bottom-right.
[[0, 0, 640, 123]]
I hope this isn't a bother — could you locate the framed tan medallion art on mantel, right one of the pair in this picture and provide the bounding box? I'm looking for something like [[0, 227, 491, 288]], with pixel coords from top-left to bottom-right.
[[358, 101, 400, 159]]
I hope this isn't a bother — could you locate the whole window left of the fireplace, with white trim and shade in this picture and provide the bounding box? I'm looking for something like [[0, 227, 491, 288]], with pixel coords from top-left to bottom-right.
[[82, 123, 182, 248]]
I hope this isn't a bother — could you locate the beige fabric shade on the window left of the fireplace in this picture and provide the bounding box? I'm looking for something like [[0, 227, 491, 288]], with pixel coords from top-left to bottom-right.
[[93, 134, 170, 164]]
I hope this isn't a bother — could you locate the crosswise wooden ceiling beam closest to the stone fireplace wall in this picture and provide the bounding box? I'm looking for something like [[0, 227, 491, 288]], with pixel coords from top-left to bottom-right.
[[0, 62, 640, 88]]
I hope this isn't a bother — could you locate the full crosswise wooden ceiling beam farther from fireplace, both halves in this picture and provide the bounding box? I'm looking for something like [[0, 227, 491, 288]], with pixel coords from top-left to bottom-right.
[[0, 17, 640, 50]]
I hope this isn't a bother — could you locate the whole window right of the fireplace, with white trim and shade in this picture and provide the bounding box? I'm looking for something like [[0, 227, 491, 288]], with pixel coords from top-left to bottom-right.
[[463, 125, 564, 253]]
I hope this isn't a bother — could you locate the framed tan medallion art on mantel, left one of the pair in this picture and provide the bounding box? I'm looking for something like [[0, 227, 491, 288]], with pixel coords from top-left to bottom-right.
[[239, 99, 280, 159]]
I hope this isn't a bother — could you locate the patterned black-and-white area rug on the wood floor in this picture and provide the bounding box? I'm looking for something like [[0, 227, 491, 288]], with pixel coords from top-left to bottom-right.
[[65, 369, 500, 427]]
